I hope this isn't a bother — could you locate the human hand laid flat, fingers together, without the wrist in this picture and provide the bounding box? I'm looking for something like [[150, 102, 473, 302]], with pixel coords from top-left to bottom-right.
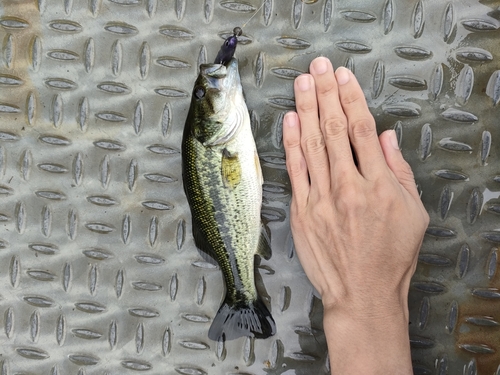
[[283, 58, 429, 373]]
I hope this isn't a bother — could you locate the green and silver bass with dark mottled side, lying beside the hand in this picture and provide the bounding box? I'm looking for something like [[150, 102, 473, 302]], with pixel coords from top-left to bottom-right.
[[181, 57, 276, 341]]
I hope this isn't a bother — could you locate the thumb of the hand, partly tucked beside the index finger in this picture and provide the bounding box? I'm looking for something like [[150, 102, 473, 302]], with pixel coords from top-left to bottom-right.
[[379, 130, 420, 201]]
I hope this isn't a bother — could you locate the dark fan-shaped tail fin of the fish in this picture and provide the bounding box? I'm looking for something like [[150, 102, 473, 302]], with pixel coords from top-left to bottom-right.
[[208, 298, 276, 341]]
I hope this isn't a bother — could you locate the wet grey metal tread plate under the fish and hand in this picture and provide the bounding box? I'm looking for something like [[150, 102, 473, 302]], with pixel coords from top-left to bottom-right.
[[0, 0, 500, 375]]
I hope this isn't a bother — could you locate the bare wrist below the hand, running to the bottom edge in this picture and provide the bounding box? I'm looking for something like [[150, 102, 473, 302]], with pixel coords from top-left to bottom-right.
[[323, 296, 412, 375]]
